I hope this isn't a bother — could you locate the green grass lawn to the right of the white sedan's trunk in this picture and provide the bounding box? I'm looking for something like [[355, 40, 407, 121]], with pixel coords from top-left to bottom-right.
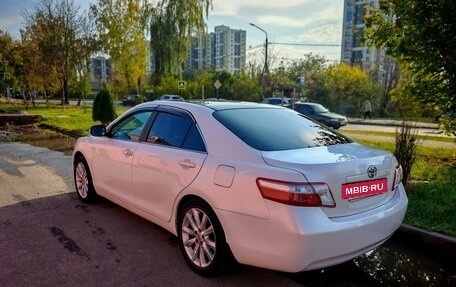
[[351, 139, 456, 237]]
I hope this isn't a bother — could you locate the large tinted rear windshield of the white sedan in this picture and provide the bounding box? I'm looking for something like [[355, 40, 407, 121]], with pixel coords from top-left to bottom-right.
[[213, 108, 352, 151]]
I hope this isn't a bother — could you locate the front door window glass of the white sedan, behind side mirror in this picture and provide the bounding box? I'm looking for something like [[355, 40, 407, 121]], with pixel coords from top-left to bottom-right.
[[111, 111, 152, 141]]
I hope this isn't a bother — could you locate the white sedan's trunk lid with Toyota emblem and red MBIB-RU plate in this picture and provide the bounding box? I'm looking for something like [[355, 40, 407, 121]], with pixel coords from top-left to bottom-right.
[[262, 143, 394, 217]]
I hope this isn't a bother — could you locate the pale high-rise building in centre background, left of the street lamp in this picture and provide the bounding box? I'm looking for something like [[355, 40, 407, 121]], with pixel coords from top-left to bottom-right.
[[186, 25, 247, 73]]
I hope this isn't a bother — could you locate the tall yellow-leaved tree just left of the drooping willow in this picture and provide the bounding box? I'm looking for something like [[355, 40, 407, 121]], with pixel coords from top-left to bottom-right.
[[90, 0, 150, 93]]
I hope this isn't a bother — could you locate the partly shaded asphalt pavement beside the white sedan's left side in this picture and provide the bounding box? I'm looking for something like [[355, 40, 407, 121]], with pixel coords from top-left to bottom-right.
[[0, 142, 302, 287]]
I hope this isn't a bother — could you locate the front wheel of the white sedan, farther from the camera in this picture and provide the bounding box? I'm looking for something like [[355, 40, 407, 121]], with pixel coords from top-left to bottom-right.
[[73, 156, 97, 203]]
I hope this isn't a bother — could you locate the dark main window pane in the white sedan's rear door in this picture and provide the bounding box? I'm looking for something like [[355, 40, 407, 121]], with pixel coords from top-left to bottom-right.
[[147, 112, 193, 147]]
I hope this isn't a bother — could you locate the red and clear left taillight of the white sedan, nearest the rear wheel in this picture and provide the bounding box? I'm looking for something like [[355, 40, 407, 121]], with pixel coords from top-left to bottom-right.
[[257, 178, 336, 207]]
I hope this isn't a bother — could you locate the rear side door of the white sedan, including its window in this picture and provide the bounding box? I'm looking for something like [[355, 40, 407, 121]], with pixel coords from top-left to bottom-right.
[[132, 107, 207, 221]]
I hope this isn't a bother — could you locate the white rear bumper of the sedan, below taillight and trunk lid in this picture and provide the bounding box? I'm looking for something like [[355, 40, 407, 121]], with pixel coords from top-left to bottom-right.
[[216, 184, 408, 272]]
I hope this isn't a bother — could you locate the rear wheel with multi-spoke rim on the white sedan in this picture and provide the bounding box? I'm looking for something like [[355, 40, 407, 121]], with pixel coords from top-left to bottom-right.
[[177, 199, 231, 276]]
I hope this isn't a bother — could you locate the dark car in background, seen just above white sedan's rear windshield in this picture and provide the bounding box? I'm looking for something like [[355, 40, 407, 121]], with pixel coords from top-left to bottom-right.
[[294, 102, 348, 129]]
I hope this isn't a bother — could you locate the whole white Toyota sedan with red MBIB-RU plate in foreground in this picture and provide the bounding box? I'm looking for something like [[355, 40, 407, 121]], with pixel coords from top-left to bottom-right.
[[73, 101, 408, 275]]
